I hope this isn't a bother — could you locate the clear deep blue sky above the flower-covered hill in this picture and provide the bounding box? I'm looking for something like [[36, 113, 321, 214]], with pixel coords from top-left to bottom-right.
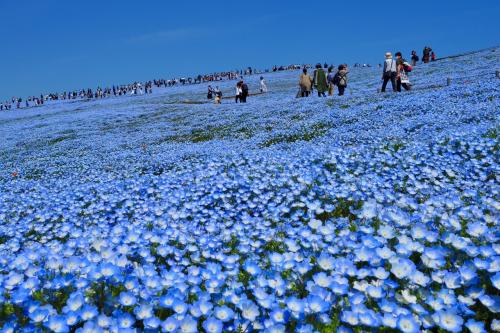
[[0, 0, 500, 100]]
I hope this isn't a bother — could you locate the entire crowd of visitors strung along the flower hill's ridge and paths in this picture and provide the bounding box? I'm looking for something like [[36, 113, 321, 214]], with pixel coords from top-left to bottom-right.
[[0, 46, 436, 111]]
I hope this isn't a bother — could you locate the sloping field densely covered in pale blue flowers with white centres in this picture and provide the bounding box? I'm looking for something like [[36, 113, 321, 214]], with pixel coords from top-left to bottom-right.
[[0, 50, 500, 333]]
